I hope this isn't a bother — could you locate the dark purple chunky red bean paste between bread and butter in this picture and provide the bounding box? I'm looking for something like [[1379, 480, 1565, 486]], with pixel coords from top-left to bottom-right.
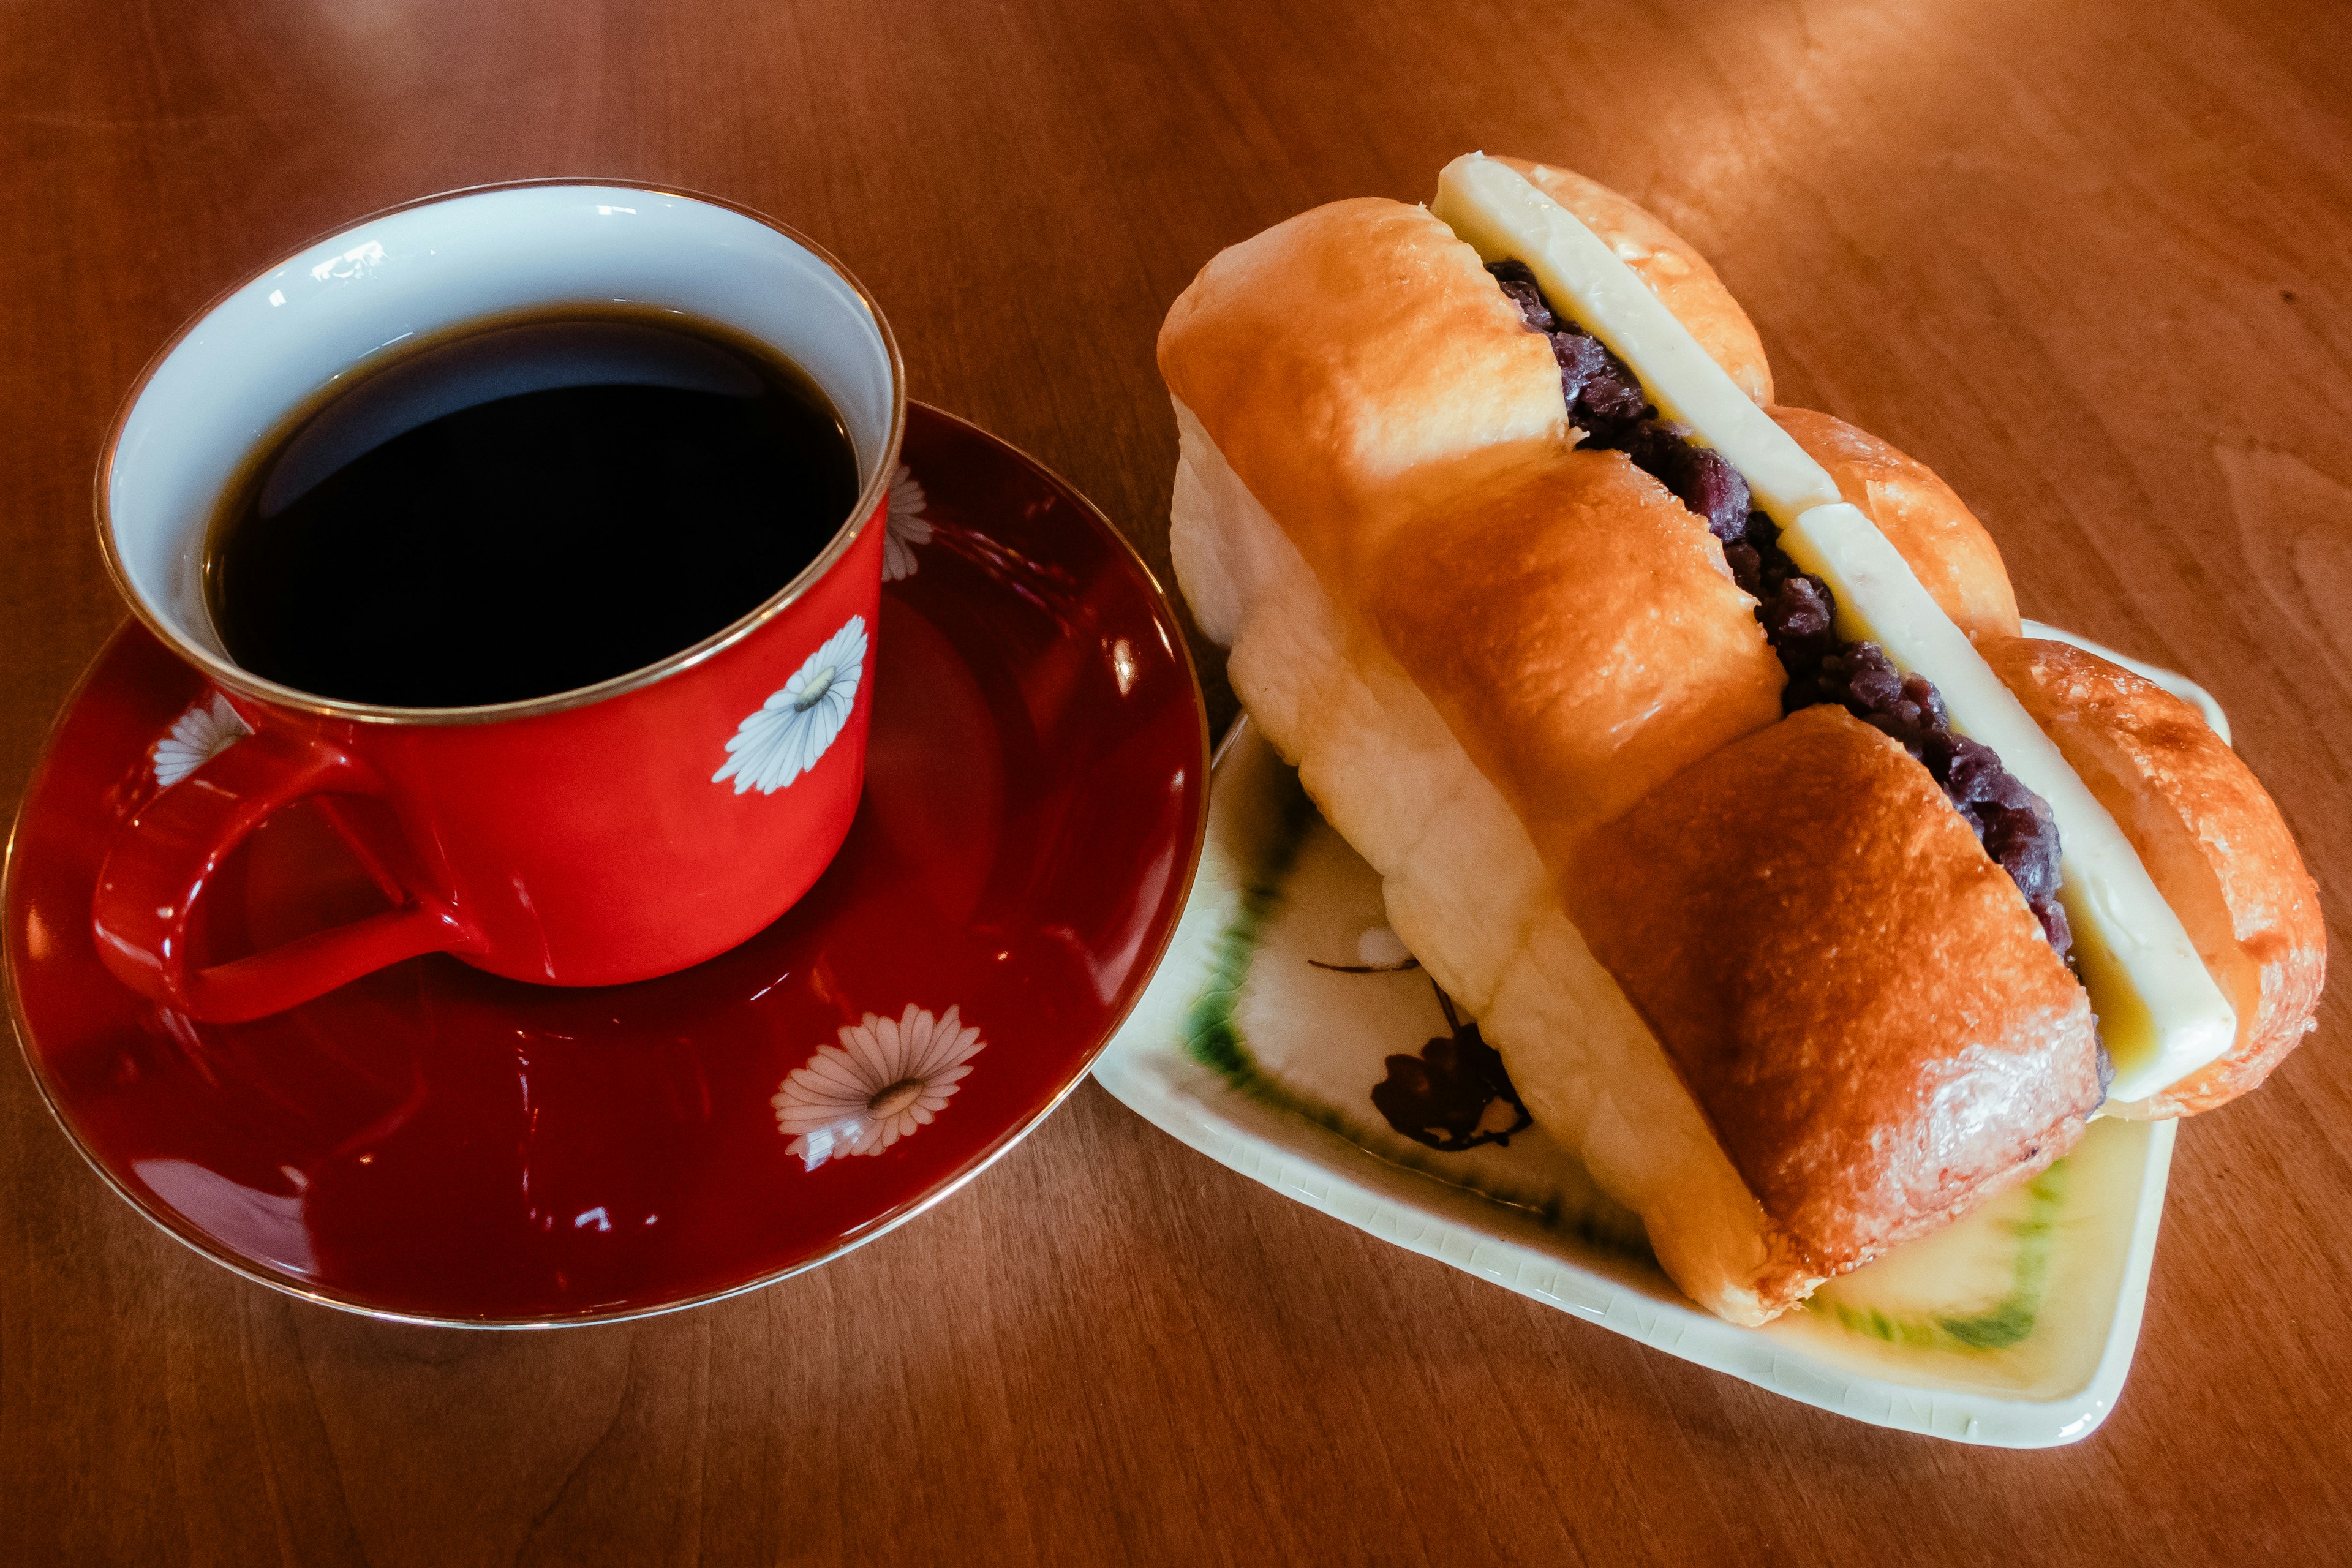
[[1487, 261, 2075, 962]]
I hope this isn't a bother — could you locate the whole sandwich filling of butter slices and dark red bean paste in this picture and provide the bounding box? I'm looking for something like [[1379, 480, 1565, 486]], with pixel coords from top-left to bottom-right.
[[1433, 153, 2237, 1100]]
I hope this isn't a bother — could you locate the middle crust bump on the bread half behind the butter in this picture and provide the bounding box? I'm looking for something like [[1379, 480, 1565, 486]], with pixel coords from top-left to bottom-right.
[[1771, 409, 2018, 642]]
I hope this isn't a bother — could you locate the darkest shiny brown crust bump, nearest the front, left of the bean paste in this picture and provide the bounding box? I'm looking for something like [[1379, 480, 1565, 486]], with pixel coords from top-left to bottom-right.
[[1564, 707, 2100, 1274]]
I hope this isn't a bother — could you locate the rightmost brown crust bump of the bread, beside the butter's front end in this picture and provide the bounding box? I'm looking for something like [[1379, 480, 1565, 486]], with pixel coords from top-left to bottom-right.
[[1983, 637, 2329, 1117]]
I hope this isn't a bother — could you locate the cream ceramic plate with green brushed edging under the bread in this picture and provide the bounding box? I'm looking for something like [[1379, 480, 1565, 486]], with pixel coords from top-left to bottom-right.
[[1094, 623, 2230, 1448]]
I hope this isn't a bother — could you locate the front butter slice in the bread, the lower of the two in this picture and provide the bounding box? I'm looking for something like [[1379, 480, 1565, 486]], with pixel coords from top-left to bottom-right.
[[1781, 501, 2237, 1102]]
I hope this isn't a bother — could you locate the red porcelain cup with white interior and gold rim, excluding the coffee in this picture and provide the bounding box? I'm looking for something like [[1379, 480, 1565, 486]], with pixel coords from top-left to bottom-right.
[[92, 181, 905, 1023]]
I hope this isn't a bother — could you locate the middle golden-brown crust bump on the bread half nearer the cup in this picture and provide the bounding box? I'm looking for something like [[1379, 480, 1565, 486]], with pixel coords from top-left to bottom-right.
[[1362, 449, 1783, 865]]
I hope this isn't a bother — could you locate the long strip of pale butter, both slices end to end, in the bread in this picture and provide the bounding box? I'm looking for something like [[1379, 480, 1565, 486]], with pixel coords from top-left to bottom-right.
[[1433, 153, 2237, 1102]]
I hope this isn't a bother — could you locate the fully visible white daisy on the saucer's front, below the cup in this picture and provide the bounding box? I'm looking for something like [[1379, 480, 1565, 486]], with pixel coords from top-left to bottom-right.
[[769, 1001, 988, 1170]]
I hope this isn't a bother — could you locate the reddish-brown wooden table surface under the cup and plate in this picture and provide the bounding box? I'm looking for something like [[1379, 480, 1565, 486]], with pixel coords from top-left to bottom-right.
[[0, 0, 2352, 1566]]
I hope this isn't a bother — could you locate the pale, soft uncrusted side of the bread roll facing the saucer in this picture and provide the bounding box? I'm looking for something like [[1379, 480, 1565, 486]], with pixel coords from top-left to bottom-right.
[[1169, 402, 1820, 1324]]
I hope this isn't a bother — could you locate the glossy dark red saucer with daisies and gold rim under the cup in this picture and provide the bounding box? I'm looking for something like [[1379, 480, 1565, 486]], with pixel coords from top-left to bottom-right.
[[5, 404, 1209, 1324]]
